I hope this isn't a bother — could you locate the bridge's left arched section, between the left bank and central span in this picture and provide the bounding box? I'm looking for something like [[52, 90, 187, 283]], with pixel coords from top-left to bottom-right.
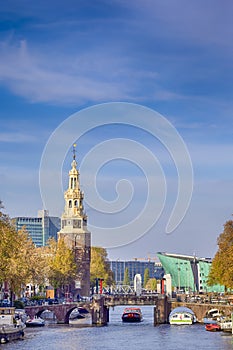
[[25, 303, 90, 324]]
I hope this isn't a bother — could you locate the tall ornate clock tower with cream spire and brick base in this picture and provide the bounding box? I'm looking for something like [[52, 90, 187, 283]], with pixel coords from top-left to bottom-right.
[[58, 145, 91, 298]]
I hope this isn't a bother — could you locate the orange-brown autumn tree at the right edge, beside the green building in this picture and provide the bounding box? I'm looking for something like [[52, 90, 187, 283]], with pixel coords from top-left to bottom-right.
[[208, 220, 233, 289]]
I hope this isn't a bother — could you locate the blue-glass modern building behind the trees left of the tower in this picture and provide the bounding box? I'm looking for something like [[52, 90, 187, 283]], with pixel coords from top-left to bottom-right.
[[11, 210, 61, 247]]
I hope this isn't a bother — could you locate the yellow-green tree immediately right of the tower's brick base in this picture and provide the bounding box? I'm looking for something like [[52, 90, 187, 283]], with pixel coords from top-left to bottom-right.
[[90, 247, 113, 287]]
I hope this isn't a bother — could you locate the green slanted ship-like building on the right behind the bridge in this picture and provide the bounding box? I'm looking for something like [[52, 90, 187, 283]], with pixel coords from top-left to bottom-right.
[[156, 253, 224, 293]]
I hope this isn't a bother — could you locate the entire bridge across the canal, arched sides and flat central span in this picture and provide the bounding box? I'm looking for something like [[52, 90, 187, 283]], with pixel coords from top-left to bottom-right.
[[25, 295, 233, 325]]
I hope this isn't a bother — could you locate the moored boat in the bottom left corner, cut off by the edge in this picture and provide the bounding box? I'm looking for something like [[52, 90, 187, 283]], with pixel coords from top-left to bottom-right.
[[0, 307, 25, 344]]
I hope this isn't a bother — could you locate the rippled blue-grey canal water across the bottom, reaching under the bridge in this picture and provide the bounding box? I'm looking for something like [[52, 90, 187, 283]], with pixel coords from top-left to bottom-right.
[[0, 306, 233, 350]]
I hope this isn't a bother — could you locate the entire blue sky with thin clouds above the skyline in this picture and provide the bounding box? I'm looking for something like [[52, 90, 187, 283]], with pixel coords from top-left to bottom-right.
[[0, 0, 233, 260]]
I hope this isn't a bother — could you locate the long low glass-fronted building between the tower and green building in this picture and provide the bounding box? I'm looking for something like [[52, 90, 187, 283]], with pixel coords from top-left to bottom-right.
[[109, 259, 164, 285]]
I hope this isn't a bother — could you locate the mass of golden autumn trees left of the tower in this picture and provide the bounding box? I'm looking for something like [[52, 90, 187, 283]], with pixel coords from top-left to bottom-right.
[[0, 201, 77, 295]]
